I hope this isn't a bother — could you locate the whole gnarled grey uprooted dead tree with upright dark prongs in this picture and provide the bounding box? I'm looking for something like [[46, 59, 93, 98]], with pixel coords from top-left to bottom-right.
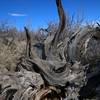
[[0, 0, 100, 100]]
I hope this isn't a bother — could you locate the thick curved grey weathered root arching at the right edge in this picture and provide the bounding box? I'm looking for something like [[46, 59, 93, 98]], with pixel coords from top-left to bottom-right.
[[66, 27, 100, 64]]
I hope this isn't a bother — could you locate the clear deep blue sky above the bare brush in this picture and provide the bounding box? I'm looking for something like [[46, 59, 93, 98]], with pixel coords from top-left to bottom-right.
[[0, 0, 100, 29]]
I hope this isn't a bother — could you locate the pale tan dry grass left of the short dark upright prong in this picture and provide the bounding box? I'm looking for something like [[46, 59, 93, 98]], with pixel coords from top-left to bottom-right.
[[0, 40, 26, 71]]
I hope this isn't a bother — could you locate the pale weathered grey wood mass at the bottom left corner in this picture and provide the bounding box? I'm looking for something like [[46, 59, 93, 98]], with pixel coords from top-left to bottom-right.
[[0, 70, 44, 100]]
